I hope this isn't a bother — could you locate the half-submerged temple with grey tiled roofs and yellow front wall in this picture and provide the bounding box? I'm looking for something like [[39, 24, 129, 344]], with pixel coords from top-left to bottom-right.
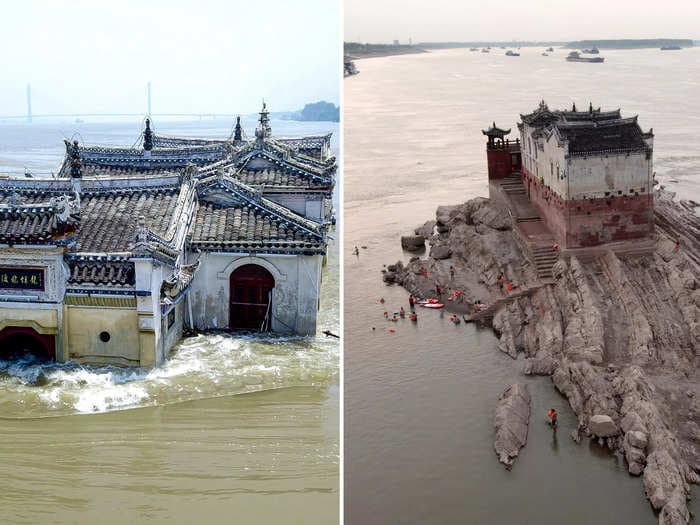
[[0, 107, 336, 366]]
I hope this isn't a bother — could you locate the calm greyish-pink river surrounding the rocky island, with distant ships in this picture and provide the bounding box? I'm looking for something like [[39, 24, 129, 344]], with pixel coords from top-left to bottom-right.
[[344, 48, 700, 525]]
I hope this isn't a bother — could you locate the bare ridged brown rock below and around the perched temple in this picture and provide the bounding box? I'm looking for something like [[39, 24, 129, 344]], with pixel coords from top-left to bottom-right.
[[388, 191, 700, 524]]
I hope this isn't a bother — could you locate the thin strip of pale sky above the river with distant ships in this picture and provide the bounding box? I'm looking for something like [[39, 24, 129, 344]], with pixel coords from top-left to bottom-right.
[[344, 0, 700, 43]]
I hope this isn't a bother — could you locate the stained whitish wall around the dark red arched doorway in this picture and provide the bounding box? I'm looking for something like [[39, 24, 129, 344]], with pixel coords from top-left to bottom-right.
[[189, 252, 323, 335]]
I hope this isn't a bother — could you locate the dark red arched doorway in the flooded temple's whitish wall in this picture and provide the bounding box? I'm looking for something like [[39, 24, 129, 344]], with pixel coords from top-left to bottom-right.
[[229, 264, 275, 332]]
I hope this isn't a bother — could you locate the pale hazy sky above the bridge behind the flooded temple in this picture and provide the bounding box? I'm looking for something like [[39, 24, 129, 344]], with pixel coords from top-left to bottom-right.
[[0, 0, 341, 115]]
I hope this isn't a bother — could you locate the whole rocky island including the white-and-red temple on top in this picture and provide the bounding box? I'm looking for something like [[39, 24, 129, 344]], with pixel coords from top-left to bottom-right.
[[384, 103, 700, 524]]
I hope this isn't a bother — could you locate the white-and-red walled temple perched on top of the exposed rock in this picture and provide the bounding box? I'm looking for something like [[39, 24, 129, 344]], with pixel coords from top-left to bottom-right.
[[483, 101, 654, 249]]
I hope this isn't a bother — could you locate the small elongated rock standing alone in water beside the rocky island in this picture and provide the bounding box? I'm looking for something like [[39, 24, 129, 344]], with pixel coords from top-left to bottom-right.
[[493, 383, 530, 468]]
